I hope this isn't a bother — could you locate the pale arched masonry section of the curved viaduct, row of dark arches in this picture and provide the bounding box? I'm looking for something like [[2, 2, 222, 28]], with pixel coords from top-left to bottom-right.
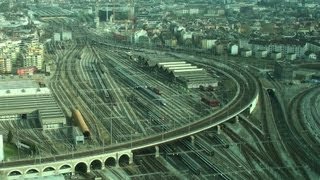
[[1, 150, 133, 179]]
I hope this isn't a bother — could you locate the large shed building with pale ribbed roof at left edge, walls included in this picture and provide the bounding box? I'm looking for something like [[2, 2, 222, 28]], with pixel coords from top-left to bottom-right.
[[0, 80, 66, 129]]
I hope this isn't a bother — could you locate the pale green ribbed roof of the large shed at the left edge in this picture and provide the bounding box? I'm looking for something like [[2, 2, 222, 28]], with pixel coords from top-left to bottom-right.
[[0, 84, 66, 125]]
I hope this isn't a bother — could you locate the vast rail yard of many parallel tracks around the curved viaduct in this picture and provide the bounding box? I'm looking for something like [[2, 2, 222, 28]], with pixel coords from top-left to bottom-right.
[[0, 20, 320, 179]]
